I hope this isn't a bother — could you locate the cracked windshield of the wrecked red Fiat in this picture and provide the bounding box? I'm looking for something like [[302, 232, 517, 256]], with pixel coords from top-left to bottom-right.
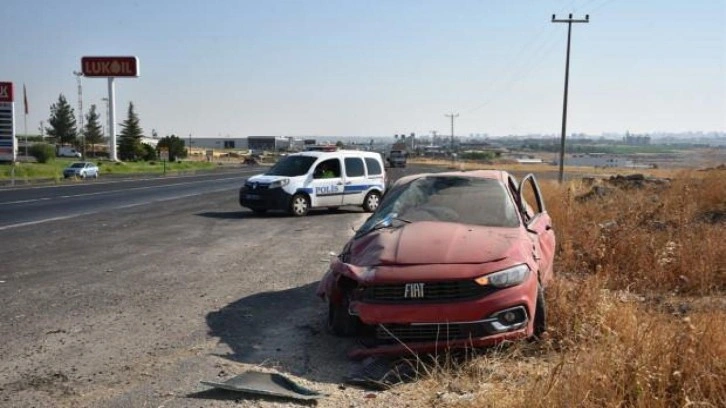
[[357, 176, 519, 236]]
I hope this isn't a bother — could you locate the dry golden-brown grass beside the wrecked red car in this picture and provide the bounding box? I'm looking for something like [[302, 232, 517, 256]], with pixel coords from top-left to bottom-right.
[[400, 167, 726, 407]]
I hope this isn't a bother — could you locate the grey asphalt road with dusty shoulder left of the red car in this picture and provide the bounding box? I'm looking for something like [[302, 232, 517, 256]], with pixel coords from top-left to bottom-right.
[[0, 164, 426, 407]]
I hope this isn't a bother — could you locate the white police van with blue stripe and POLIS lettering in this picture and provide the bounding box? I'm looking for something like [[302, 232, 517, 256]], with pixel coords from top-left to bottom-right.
[[239, 150, 386, 216]]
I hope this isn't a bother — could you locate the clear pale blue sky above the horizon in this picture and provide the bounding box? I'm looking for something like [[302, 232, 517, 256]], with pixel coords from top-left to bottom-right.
[[0, 0, 726, 137]]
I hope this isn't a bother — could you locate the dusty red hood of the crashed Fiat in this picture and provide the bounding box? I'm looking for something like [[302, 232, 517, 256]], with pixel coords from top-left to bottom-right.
[[350, 221, 526, 266]]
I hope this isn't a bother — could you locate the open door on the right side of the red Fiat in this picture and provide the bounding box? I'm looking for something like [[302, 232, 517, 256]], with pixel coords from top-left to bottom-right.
[[518, 174, 555, 284]]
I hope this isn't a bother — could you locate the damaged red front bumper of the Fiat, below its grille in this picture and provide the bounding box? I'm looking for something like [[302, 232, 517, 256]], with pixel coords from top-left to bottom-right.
[[350, 274, 537, 358]]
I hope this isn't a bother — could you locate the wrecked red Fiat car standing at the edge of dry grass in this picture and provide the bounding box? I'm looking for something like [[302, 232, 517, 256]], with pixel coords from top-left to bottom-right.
[[317, 170, 555, 357]]
